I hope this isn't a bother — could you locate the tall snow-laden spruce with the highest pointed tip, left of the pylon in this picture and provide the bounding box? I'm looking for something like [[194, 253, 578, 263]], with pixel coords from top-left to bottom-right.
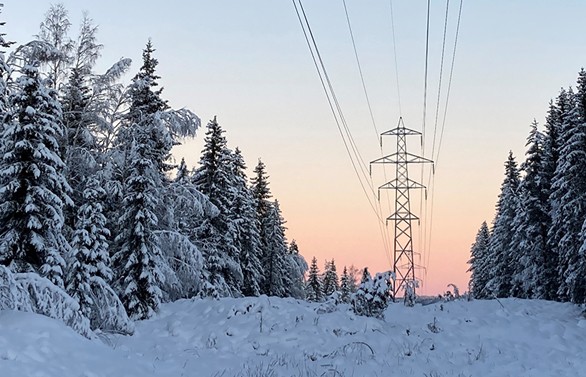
[[112, 41, 173, 319]]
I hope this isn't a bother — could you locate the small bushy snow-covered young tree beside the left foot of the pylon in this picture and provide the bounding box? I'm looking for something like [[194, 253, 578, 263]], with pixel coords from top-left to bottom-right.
[[351, 269, 393, 318]]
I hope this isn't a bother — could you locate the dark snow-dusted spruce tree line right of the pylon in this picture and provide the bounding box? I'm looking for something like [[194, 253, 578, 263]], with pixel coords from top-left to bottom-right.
[[469, 69, 586, 304]]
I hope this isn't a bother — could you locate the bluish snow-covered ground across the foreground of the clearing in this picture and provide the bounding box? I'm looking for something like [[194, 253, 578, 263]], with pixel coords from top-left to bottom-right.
[[0, 297, 586, 377]]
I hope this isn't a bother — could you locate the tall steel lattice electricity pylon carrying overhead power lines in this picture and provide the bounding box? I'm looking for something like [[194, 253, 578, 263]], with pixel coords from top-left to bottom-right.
[[370, 118, 433, 297]]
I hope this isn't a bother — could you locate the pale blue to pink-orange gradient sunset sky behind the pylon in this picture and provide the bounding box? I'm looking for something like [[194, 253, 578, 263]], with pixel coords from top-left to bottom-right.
[[2, 0, 586, 294]]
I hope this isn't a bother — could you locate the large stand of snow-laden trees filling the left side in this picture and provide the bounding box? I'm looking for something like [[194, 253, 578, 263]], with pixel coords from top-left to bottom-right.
[[0, 5, 307, 328]]
